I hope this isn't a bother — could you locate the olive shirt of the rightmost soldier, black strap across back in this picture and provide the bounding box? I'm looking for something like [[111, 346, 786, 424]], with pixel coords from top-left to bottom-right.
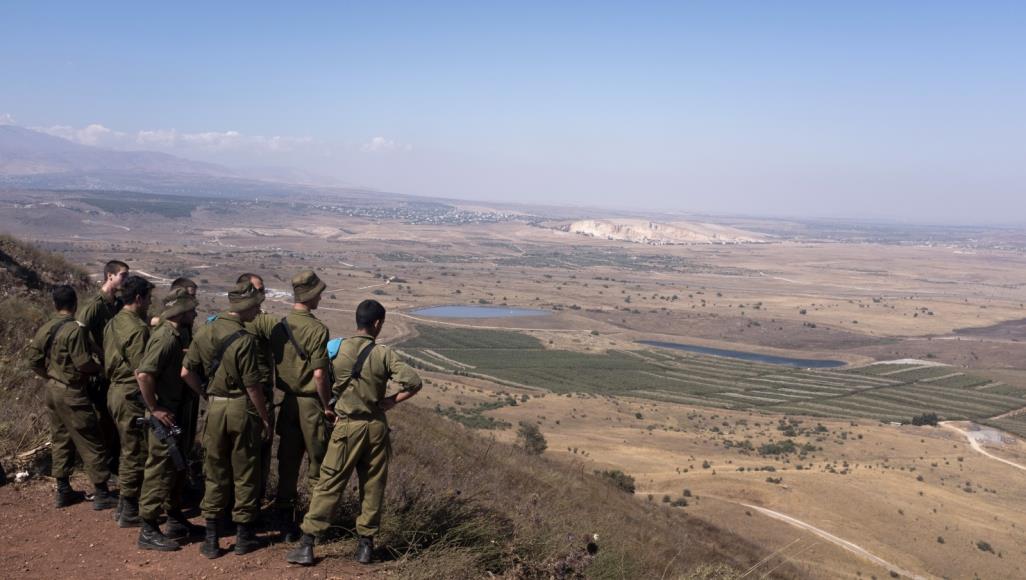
[[332, 336, 423, 417]]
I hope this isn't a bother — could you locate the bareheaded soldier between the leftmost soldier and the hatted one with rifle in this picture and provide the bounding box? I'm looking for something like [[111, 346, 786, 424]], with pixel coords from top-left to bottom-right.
[[104, 276, 153, 528]]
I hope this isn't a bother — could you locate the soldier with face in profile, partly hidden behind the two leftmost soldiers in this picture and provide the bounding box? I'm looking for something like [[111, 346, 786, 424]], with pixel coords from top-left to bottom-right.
[[78, 260, 128, 472]]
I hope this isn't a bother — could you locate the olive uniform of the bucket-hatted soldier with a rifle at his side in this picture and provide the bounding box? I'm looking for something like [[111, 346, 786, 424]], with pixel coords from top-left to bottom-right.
[[136, 323, 195, 520]]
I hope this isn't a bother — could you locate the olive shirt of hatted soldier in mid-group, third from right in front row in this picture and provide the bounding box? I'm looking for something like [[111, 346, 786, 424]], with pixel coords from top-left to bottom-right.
[[184, 312, 270, 396]]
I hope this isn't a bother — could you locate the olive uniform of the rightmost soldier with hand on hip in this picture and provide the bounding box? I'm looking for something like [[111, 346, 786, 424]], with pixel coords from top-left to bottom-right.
[[303, 336, 422, 536]]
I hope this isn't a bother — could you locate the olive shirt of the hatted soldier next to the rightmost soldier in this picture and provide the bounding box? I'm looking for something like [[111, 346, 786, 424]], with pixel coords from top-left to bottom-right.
[[271, 310, 328, 396]]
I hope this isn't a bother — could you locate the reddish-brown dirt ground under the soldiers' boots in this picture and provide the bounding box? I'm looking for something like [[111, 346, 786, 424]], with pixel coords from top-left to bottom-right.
[[0, 480, 390, 579]]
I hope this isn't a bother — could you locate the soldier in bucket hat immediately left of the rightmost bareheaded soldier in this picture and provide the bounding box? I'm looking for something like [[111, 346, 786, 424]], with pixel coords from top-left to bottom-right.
[[271, 270, 336, 542]]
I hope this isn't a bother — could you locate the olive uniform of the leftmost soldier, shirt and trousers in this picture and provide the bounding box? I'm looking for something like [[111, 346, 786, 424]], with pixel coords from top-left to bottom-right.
[[28, 314, 111, 485]]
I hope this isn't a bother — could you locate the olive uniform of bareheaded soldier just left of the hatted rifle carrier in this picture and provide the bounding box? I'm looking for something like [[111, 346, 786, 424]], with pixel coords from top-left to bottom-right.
[[104, 310, 150, 498]]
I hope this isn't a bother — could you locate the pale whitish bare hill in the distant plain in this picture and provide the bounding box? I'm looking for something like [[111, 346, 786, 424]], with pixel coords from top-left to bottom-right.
[[568, 220, 765, 245]]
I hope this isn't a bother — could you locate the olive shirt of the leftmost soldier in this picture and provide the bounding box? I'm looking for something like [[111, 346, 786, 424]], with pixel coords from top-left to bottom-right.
[[27, 314, 92, 387]]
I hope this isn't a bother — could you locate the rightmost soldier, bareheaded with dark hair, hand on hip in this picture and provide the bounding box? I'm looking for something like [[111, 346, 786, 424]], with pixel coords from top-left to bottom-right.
[[285, 300, 422, 566]]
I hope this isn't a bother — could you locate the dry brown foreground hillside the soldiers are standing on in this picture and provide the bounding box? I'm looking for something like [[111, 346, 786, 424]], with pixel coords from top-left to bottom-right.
[[0, 237, 804, 578]]
